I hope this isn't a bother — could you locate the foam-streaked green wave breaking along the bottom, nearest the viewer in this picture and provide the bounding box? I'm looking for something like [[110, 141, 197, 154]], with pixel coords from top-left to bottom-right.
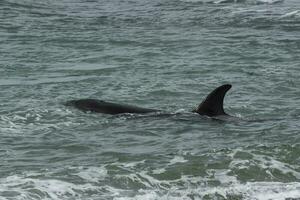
[[0, 145, 300, 200]]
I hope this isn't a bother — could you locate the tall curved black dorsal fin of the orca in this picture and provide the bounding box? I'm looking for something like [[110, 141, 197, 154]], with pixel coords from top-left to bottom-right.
[[194, 84, 231, 117]]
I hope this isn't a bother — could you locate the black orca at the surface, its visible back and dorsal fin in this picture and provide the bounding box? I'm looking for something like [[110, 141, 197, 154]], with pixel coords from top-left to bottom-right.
[[66, 84, 231, 117]]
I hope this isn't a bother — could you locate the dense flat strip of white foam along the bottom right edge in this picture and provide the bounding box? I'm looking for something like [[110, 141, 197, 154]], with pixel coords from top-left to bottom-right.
[[109, 182, 300, 200]]
